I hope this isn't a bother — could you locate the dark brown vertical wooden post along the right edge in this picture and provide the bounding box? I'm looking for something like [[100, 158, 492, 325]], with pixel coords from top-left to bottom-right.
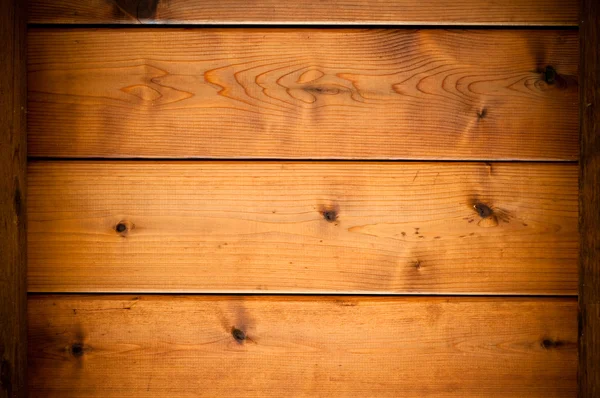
[[579, 0, 600, 398]]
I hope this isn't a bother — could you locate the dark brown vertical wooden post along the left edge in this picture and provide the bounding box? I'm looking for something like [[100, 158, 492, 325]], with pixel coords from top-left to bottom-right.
[[0, 0, 27, 398]]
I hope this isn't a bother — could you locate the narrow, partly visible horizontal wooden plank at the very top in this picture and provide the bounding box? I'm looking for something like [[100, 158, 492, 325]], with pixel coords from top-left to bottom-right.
[[29, 0, 578, 26]]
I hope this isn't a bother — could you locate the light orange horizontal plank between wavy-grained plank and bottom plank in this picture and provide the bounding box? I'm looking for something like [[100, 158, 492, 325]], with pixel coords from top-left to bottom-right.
[[28, 161, 578, 295]]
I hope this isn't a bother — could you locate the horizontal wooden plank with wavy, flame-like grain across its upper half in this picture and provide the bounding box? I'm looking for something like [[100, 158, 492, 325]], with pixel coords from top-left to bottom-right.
[[28, 29, 579, 160]]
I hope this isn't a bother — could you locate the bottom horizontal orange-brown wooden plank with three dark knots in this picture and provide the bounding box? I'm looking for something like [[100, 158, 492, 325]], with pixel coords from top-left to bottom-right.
[[28, 295, 577, 398]]
